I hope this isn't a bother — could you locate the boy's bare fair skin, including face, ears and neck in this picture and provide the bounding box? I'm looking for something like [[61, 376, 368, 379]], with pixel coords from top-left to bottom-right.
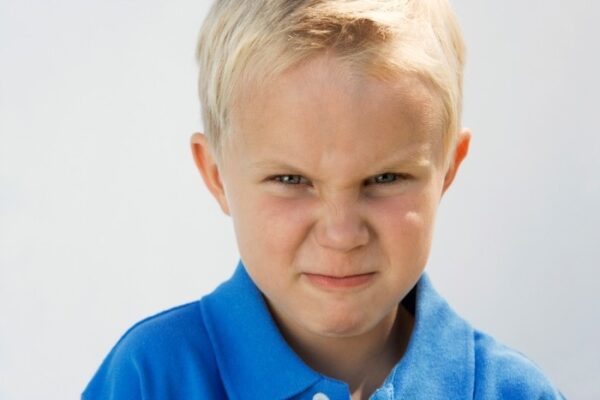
[[192, 55, 470, 399]]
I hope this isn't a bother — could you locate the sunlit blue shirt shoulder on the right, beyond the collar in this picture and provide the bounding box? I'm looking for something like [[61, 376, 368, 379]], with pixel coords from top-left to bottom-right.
[[474, 331, 563, 399]]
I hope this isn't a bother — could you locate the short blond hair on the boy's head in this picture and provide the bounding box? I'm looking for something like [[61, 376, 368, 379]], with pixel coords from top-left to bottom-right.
[[196, 0, 465, 159]]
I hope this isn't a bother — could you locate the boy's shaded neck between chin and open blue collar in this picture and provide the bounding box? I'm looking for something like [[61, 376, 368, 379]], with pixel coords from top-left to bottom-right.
[[276, 305, 414, 399]]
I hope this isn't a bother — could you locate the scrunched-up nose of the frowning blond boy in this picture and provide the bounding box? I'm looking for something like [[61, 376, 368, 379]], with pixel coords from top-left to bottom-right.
[[315, 195, 370, 252]]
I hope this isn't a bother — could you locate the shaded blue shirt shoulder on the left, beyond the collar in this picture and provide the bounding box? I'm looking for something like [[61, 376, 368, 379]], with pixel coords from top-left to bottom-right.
[[82, 300, 222, 400]]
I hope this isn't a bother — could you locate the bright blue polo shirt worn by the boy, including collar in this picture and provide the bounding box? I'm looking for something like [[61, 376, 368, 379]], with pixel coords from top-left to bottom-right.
[[82, 263, 562, 400]]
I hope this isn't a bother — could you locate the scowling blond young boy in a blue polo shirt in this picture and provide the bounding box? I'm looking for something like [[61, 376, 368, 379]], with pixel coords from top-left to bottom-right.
[[83, 0, 561, 400]]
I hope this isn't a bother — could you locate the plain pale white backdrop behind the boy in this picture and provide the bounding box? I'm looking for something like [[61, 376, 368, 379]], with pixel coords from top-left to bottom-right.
[[0, 0, 600, 400]]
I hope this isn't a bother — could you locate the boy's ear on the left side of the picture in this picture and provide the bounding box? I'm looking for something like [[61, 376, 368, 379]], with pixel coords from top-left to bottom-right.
[[191, 133, 229, 215]]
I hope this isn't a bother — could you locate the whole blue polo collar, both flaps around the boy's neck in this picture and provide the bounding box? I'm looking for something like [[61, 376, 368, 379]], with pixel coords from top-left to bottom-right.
[[201, 261, 475, 399]]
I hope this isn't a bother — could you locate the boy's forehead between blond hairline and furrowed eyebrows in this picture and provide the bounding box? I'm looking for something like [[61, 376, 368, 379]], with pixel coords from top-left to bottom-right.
[[229, 55, 444, 170]]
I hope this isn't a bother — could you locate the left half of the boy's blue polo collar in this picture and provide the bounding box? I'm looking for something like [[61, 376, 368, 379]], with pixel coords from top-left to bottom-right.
[[202, 262, 321, 399]]
